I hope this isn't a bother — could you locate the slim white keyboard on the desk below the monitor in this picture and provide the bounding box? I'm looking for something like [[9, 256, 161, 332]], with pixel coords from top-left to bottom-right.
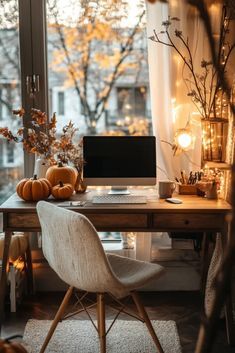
[[92, 195, 147, 204]]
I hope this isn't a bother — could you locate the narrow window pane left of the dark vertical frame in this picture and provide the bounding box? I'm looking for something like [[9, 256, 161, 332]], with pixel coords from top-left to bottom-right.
[[0, 0, 23, 203]]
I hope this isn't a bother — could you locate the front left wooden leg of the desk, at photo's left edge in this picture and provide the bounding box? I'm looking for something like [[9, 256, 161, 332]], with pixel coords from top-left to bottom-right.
[[0, 231, 12, 331]]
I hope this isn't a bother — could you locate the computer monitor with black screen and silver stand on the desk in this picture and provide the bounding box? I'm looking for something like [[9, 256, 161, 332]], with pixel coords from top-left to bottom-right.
[[83, 136, 156, 193]]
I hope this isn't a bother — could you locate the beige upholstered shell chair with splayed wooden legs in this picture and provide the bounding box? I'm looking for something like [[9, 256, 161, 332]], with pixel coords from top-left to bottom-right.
[[37, 201, 164, 353]]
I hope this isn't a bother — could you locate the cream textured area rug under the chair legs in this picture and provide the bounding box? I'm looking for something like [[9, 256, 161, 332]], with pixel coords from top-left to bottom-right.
[[23, 320, 181, 353]]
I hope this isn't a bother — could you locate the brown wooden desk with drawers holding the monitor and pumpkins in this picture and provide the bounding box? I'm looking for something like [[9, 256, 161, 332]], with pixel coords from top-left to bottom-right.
[[0, 190, 232, 336]]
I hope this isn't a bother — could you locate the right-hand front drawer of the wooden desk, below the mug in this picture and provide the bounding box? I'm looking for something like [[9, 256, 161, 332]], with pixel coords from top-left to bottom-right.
[[153, 213, 224, 231]]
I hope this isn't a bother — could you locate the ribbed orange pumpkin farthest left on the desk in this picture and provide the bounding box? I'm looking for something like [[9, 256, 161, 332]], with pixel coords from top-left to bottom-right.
[[16, 175, 51, 201]]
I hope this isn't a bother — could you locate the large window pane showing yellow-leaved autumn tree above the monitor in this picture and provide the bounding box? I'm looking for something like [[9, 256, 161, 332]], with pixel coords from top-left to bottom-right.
[[47, 0, 151, 135]]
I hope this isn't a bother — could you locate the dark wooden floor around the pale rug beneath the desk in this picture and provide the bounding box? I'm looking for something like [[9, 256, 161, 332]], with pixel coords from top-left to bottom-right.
[[2, 292, 235, 353]]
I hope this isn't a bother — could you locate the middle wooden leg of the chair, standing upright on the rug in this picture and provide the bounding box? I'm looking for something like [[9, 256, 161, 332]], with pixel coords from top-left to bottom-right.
[[97, 293, 106, 353]]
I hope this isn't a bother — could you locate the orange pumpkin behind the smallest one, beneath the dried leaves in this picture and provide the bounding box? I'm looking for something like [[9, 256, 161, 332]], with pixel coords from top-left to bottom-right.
[[46, 163, 78, 187]]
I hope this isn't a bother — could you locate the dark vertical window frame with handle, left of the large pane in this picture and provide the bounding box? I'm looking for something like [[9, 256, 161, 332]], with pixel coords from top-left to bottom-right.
[[18, 0, 48, 177]]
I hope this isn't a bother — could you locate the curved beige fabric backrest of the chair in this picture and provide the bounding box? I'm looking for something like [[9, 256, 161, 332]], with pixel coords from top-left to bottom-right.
[[37, 201, 121, 292]]
